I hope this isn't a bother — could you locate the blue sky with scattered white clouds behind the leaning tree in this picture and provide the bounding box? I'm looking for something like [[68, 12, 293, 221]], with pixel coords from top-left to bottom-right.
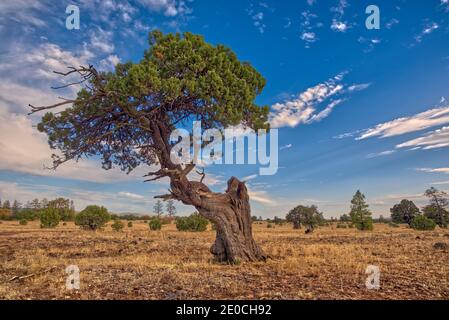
[[0, 0, 449, 217]]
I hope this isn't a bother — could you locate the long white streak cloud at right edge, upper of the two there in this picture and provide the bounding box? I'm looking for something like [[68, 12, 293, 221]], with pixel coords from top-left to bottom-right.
[[356, 106, 449, 140]]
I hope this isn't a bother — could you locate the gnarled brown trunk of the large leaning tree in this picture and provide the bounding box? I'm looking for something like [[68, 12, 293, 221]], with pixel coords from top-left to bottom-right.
[[150, 121, 267, 263]]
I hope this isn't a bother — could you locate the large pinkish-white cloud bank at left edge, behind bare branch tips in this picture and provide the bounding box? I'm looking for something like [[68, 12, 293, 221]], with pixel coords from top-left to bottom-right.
[[0, 43, 147, 182]]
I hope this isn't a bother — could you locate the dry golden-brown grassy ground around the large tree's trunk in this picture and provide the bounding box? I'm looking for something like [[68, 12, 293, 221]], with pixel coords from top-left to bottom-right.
[[0, 221, 449, 299]]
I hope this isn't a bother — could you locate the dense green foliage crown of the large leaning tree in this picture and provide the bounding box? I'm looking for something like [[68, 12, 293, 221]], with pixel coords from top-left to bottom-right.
[[36, 31, 269, 172]]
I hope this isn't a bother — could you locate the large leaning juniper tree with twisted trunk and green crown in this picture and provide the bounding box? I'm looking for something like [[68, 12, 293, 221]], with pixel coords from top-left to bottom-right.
[[30, 31, 269, 262]]
